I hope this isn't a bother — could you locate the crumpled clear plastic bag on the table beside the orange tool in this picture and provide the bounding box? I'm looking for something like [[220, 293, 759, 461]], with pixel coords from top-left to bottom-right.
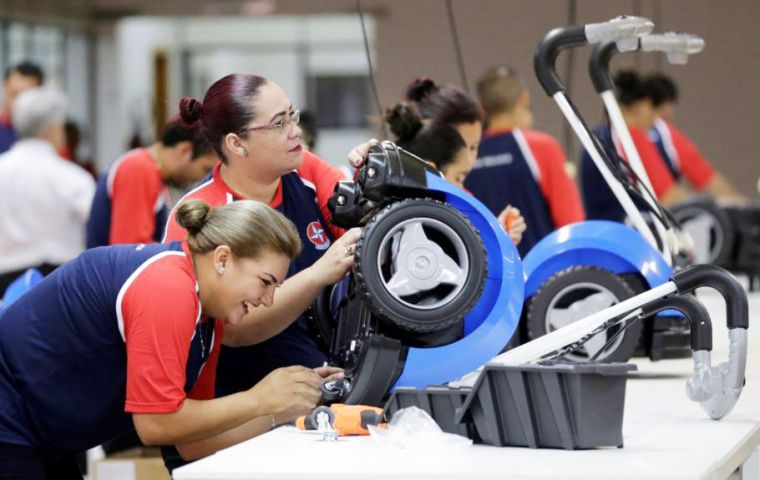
[[368, 407, 472, 451]]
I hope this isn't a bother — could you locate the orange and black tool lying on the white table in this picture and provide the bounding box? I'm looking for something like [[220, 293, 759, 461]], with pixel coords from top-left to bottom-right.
[[296, 403, 384, 436]]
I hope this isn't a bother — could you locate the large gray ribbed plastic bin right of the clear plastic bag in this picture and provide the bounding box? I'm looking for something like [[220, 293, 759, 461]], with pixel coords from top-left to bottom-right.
[[456, 363, 636, 450]]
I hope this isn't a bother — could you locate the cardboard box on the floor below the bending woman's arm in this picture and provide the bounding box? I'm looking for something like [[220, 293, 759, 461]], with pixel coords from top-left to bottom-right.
[[93, 448, 171, 480]]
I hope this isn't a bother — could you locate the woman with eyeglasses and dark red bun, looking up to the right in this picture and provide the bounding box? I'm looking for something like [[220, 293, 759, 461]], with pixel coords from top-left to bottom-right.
[[164, 73, 368, 468]]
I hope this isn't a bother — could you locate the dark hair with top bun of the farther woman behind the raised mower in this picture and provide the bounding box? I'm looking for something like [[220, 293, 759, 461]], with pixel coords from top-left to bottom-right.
[[406, 77, 483, 125]]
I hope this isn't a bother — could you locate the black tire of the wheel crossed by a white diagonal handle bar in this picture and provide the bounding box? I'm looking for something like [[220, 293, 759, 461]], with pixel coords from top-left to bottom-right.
[[525, 266, 644, 362]]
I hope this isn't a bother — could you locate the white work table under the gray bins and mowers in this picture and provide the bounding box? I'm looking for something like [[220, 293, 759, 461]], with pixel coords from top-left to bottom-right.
[[174, 286, 760, 480]]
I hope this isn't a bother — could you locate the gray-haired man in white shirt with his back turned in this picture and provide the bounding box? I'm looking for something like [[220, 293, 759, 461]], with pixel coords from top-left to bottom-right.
[[0, 88, 95, 298]]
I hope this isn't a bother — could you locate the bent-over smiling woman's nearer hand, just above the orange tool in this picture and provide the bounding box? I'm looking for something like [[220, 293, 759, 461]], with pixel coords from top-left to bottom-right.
[[248, 366, 324, 423]]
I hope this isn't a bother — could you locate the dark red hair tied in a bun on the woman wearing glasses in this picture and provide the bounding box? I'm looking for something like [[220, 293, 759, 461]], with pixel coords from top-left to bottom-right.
[[179, 73, 268, 162]]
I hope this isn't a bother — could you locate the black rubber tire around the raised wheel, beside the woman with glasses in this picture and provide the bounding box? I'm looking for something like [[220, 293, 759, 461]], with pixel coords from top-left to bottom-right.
[[354, 198, 487, 333]]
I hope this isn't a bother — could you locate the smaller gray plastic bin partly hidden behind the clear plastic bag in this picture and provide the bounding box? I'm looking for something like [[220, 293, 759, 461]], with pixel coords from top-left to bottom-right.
[[384, 386, 477, 440]]
